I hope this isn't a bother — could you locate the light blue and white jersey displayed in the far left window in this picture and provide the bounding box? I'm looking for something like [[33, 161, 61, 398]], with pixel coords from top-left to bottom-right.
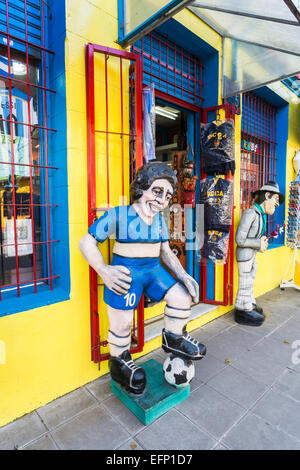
[[0, 88, 38, 179]]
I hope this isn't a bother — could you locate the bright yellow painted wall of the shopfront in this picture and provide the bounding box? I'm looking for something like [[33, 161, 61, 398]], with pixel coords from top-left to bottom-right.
[[0, 0, 300, 426]]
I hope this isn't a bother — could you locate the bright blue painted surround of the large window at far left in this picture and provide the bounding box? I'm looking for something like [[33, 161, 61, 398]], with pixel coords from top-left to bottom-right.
[[0, 0, 70, 317]]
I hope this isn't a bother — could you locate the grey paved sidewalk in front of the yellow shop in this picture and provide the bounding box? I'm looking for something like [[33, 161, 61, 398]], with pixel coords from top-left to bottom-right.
[[0, 288, 300, 450]]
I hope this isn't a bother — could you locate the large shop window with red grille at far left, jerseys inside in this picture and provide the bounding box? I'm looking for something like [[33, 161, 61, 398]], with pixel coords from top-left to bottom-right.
[[0, 0, 59, 299]]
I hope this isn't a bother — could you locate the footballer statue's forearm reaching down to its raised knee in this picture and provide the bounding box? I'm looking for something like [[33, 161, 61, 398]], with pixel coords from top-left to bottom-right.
[[160, 242, 199, 303]]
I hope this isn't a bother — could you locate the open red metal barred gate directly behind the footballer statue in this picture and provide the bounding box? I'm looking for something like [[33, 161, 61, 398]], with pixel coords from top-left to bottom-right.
[[86, 44, 144, 363]]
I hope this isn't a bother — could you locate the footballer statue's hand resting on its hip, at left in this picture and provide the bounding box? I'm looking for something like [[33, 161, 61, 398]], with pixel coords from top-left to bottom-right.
[[98, 264, 132, 295]]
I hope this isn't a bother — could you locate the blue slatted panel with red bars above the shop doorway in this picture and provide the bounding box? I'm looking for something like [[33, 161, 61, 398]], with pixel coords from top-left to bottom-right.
[[131, 31, 203, 107]]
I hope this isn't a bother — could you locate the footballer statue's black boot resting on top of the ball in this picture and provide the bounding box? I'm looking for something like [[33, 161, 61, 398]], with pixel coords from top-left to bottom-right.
[[162, 327, 206, 361]]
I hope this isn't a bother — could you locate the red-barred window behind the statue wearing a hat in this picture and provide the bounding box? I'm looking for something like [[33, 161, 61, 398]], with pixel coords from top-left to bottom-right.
[[240, 92, 277, 231]]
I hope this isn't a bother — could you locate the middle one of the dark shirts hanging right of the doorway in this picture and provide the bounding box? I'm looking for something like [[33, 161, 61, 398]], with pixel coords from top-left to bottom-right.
[[200, 178, 233, 232]]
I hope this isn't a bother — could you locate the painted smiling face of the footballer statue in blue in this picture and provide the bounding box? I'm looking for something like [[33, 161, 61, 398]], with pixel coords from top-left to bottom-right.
[[136, 179, 173, 217]]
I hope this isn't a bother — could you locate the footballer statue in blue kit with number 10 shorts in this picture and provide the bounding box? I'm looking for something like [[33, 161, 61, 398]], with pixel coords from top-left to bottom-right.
[[80, 161, 206, 394]]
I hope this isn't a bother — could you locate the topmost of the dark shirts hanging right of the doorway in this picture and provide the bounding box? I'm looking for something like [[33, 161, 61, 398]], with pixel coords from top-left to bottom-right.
[[201, 121, 235, 175]]
